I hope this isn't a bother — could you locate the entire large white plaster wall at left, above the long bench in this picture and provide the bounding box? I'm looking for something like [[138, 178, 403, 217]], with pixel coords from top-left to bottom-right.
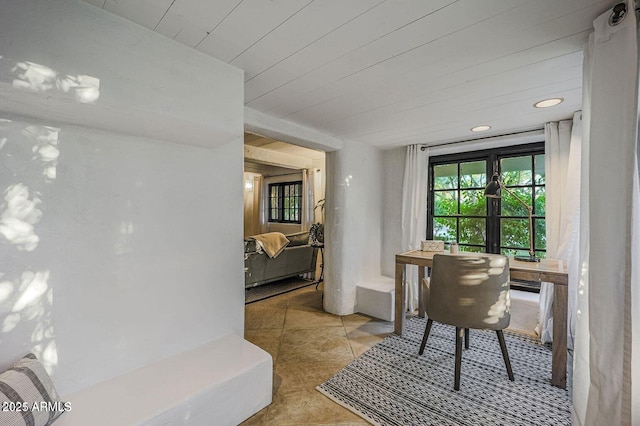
[[0, 0, 244, 394]]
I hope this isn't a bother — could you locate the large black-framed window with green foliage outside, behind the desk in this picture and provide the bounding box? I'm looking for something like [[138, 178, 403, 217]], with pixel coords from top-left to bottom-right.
[[427, 143, 546, 257]]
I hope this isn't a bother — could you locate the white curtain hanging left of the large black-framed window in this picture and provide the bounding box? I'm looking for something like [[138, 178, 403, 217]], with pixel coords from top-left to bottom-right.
[[402, 145, 429, 311]]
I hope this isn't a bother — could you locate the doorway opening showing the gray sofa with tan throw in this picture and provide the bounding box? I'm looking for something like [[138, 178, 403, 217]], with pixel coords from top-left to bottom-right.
[[243, 133, 326, 301]]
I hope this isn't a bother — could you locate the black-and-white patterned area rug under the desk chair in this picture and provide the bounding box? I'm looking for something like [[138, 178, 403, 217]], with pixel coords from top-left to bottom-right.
[[317, 317, 571, 426]]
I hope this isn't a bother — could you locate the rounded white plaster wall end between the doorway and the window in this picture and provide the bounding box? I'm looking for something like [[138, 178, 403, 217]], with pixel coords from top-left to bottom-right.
[[324, 142, 383, 315]]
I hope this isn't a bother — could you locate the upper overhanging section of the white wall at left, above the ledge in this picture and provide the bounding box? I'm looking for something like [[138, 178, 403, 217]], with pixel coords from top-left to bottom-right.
[[0, 0, 244, 150]]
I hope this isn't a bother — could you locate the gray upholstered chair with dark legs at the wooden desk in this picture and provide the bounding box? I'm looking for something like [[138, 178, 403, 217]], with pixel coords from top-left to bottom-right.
[[419, 254, 514, 390]]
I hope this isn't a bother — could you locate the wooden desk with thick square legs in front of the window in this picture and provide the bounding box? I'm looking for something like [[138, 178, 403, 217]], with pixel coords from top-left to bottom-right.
[[394, 250, 569, 389]]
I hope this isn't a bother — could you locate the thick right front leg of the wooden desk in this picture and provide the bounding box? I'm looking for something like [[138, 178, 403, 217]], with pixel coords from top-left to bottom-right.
[[551, 284, 569, 389]]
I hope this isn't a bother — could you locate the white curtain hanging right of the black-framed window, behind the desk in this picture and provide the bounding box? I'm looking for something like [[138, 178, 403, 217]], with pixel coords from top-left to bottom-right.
[[536, 115, 582, 349]]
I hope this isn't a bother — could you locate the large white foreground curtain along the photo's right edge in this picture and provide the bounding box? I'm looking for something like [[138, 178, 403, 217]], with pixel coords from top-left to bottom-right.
[[573, 1, 640, 425]]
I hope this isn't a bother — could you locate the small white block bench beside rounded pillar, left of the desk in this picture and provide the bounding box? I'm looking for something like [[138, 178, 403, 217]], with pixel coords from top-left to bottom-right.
[[355, 276, 395, 321]]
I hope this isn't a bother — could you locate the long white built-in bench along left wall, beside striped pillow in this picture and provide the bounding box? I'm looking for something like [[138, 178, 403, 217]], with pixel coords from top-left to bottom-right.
[[55, 334, 273, 426]]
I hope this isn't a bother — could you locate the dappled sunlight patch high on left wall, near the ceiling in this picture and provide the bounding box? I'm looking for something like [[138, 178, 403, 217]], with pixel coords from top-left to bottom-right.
[[10, 57, 100, 103]]
